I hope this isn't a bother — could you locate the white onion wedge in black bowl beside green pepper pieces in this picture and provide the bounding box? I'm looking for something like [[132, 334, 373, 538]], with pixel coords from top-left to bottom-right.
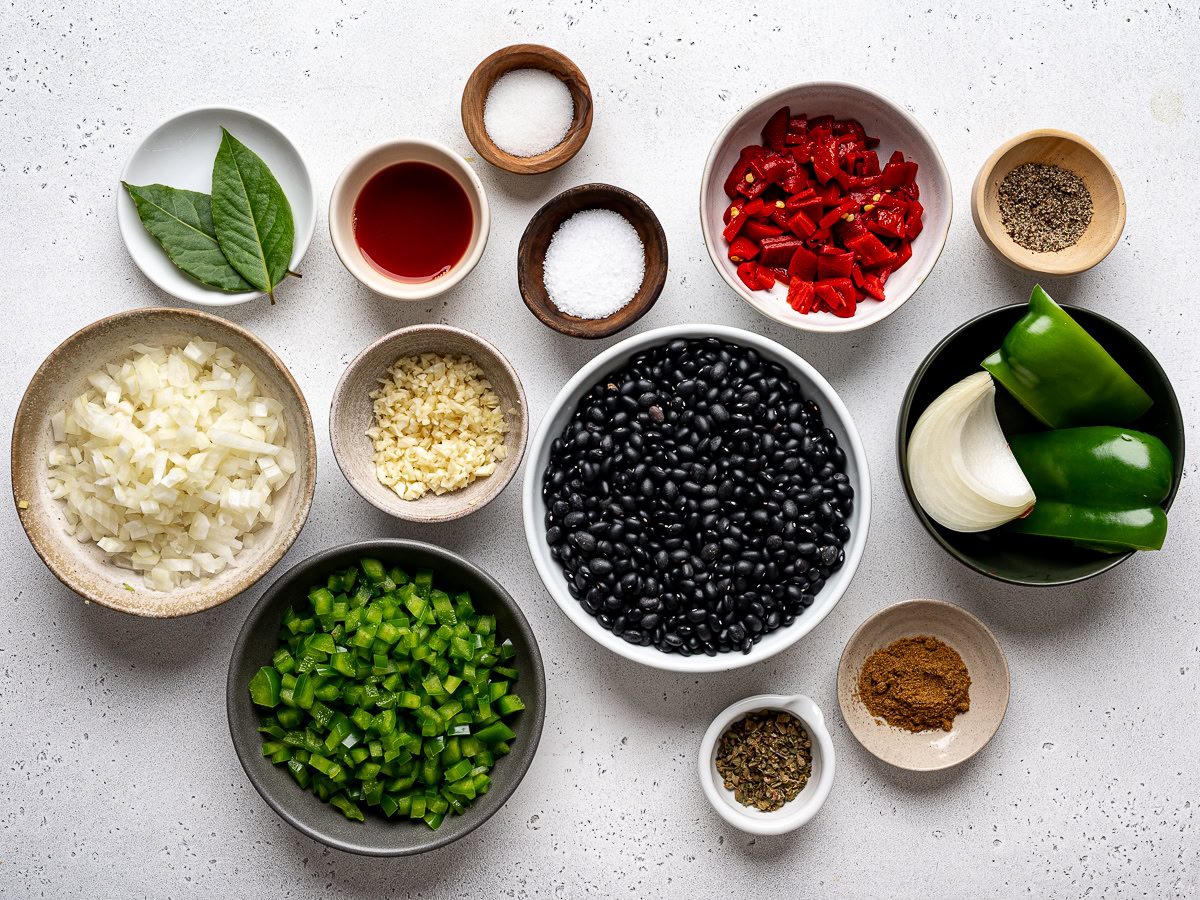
[[908, 372, 1036, 532]]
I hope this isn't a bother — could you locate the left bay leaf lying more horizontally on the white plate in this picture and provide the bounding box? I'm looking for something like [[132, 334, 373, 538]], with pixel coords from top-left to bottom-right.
[[121, 181, 253, 290]]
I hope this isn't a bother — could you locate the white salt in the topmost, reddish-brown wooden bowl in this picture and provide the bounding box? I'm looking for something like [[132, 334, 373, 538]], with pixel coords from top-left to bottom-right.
[[484, 68, 575, 156]]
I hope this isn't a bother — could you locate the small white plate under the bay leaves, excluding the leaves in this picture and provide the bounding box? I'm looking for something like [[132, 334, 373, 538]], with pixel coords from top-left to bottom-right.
[[116, 107, 317, 306]]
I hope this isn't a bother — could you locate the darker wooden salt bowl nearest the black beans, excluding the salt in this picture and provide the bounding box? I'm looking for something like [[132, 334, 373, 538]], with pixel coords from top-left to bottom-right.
[[517, 185, 667, 338]]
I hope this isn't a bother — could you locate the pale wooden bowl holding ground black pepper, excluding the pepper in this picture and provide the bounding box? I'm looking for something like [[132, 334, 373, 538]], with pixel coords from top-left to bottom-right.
[[971, 128, 1127, 276]]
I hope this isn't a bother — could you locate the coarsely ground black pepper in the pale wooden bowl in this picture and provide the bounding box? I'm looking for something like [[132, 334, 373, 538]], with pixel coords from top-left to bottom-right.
[[998, 162, 1092, 253]]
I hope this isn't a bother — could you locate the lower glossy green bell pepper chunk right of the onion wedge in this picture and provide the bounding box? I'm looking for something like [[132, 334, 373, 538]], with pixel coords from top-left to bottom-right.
[[1007, 425, 1174, 553]]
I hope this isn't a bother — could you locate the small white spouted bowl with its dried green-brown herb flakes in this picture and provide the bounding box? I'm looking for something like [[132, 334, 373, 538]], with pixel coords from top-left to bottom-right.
[[700, 694, 834, 834]]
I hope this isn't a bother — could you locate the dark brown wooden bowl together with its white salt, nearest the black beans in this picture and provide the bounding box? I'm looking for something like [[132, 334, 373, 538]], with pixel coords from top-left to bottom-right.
[[517, 185, 667, 338]]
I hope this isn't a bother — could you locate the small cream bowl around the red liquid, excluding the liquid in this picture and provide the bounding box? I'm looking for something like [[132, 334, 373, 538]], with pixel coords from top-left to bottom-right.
[[329, 138, 492, 300]]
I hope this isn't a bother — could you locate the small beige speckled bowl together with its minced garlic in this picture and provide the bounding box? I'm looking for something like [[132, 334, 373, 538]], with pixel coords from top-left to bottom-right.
[[329, 325, 528, 522]]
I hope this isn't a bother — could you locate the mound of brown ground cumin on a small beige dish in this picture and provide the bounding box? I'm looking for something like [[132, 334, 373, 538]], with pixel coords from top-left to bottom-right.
[[858, 635, 971, 731]]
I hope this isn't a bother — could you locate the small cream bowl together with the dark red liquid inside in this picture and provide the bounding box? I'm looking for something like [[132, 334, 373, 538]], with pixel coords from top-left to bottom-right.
[[329, 138, 492, 300]]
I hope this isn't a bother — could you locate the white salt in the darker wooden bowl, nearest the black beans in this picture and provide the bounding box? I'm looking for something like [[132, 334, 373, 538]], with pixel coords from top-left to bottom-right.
[[542, 209, 646, 319]]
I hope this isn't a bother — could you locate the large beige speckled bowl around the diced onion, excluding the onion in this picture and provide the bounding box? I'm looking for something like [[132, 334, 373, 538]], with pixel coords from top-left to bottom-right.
[[12, 307, 317, 618]]
